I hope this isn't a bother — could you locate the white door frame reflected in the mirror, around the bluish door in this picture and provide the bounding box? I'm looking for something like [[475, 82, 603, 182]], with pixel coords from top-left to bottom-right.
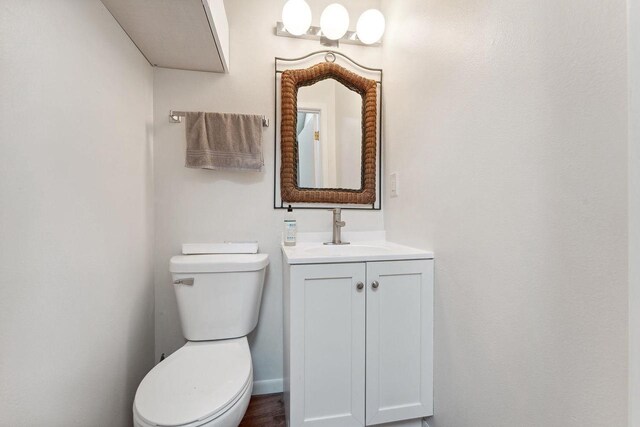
[[298, 102, 336, 188]]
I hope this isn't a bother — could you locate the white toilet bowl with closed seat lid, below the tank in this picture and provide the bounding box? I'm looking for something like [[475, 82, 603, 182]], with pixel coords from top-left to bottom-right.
[[133, 337, 253, 426]]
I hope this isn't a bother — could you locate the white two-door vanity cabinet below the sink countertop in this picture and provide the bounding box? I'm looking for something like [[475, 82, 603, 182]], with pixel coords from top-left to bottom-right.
[[284, 242, 433, 427]]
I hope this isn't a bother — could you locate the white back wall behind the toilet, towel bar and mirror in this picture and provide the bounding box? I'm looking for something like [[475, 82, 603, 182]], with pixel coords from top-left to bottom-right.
[[154, 0, 383, 392]]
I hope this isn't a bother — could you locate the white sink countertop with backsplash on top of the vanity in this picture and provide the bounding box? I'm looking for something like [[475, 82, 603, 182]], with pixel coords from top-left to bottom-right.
[[282, 232, 433, 264]]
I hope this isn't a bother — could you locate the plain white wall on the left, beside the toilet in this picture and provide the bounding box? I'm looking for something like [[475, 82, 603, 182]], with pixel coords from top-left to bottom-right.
[[0, 0, 153, 426]]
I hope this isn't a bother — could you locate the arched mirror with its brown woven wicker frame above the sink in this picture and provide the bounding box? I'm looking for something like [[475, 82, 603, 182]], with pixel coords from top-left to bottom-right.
[[280, 56, 379, 205]]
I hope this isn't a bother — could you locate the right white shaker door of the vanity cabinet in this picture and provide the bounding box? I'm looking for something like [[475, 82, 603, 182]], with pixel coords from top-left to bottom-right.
[[366, 260, 433, 425]]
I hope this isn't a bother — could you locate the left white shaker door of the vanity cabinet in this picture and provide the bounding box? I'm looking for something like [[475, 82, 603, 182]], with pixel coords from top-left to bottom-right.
[[290, 263, 366, 427]]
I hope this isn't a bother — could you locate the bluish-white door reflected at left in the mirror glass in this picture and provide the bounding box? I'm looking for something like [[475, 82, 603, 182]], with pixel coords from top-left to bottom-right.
[[296, 109, 323, 188]]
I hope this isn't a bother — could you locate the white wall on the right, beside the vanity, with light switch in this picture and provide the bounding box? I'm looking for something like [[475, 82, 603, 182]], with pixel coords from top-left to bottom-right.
[[383, 0, 628, 427]]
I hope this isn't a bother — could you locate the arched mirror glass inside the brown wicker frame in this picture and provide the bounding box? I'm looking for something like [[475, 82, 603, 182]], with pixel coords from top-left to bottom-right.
[[296, 78, 362, 189]]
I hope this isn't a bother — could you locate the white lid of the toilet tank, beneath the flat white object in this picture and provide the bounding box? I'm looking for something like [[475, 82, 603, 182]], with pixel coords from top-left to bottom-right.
[[169, 254, 269, 273]]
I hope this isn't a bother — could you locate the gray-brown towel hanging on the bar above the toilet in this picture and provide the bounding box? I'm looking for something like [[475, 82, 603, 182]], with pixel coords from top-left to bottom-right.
[[185, 112, 264, 171]]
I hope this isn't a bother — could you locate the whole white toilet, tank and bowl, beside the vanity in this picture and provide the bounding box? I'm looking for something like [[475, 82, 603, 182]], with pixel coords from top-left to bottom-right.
[[133, 247, 269, 427]]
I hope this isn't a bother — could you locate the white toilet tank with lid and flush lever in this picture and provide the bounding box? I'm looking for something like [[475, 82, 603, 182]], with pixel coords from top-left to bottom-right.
[[170, 254, 269, 341]]
